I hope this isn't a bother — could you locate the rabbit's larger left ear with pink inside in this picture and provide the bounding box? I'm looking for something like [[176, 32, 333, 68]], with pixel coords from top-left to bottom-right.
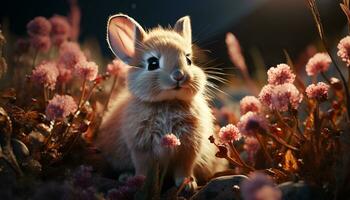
[[107, 14, 146, 63]]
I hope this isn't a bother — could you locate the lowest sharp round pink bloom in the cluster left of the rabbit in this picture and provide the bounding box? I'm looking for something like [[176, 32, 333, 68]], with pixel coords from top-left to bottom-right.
[[46, 95, 78, 120]]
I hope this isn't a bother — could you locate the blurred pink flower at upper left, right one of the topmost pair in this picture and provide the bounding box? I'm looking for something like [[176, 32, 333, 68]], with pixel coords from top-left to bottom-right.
[[50, 15, 70, 46]]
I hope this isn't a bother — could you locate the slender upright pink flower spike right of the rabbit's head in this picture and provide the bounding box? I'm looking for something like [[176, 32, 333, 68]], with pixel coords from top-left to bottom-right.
[[225, 33, 247, 73]]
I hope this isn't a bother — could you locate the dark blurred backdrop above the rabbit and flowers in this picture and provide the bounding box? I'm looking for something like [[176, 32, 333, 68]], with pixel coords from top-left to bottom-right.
[[0, 0, 346, 70]]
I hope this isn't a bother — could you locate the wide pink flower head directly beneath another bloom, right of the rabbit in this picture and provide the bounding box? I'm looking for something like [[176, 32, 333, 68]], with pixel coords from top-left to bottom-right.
[[259, 83, 303, 111]]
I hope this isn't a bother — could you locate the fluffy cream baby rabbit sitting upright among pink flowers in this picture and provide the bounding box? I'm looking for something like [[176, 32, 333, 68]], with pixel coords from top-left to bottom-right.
[[96, 14, 227, 188]]
